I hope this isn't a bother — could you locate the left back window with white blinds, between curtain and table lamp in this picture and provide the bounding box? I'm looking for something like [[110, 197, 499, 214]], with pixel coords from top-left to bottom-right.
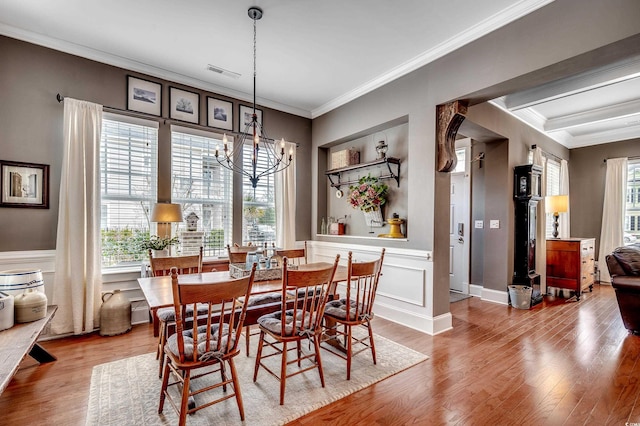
[[100, 113, 158, 267]]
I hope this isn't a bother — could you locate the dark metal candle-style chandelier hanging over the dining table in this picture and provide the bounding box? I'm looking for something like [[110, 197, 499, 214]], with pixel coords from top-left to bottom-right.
[[216, 6, 293, 189]]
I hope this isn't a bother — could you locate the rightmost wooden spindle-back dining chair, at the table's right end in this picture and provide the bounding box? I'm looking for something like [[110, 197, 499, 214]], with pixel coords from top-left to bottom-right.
[[322, 248, 385, 380]]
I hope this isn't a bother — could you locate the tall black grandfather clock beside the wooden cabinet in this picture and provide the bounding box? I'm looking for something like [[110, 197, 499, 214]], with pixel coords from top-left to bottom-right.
[[513, 164, 542, 305]]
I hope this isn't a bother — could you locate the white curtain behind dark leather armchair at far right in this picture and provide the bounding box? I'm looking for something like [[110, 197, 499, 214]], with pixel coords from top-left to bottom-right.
[[598, 158, 627, 282]]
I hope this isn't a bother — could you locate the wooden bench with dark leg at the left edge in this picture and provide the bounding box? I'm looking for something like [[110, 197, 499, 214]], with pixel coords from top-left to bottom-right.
[[0, 305, 58, 394]]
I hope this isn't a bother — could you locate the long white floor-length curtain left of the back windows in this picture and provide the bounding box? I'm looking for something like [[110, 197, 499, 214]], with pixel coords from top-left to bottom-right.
[[51, 98, 102, 334]]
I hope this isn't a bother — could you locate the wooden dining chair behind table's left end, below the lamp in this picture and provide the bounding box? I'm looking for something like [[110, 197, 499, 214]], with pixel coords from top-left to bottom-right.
[[149, 247, 203, 377]]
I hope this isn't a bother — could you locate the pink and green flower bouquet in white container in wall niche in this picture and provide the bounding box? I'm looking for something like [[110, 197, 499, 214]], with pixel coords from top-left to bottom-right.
[[348, 175, 389, 227]]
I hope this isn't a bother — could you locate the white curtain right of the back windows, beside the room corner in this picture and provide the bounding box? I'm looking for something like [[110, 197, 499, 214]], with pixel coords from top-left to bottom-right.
[[275, 142, 296, 249]]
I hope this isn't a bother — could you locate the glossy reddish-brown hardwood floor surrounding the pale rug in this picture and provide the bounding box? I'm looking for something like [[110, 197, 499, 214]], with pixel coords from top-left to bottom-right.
[[0, 285, 640, 425]]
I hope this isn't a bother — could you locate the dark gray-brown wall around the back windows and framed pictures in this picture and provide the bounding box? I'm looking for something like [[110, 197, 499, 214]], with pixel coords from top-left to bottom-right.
[[0, 36, 311, 251]]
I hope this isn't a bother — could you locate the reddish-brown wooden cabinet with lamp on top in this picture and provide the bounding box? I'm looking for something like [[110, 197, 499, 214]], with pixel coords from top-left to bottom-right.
[[547, 238, 596, 300]]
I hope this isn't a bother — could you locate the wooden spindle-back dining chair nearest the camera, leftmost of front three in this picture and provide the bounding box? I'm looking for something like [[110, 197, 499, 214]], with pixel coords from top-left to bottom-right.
[[158, 265, 255, 426]]
